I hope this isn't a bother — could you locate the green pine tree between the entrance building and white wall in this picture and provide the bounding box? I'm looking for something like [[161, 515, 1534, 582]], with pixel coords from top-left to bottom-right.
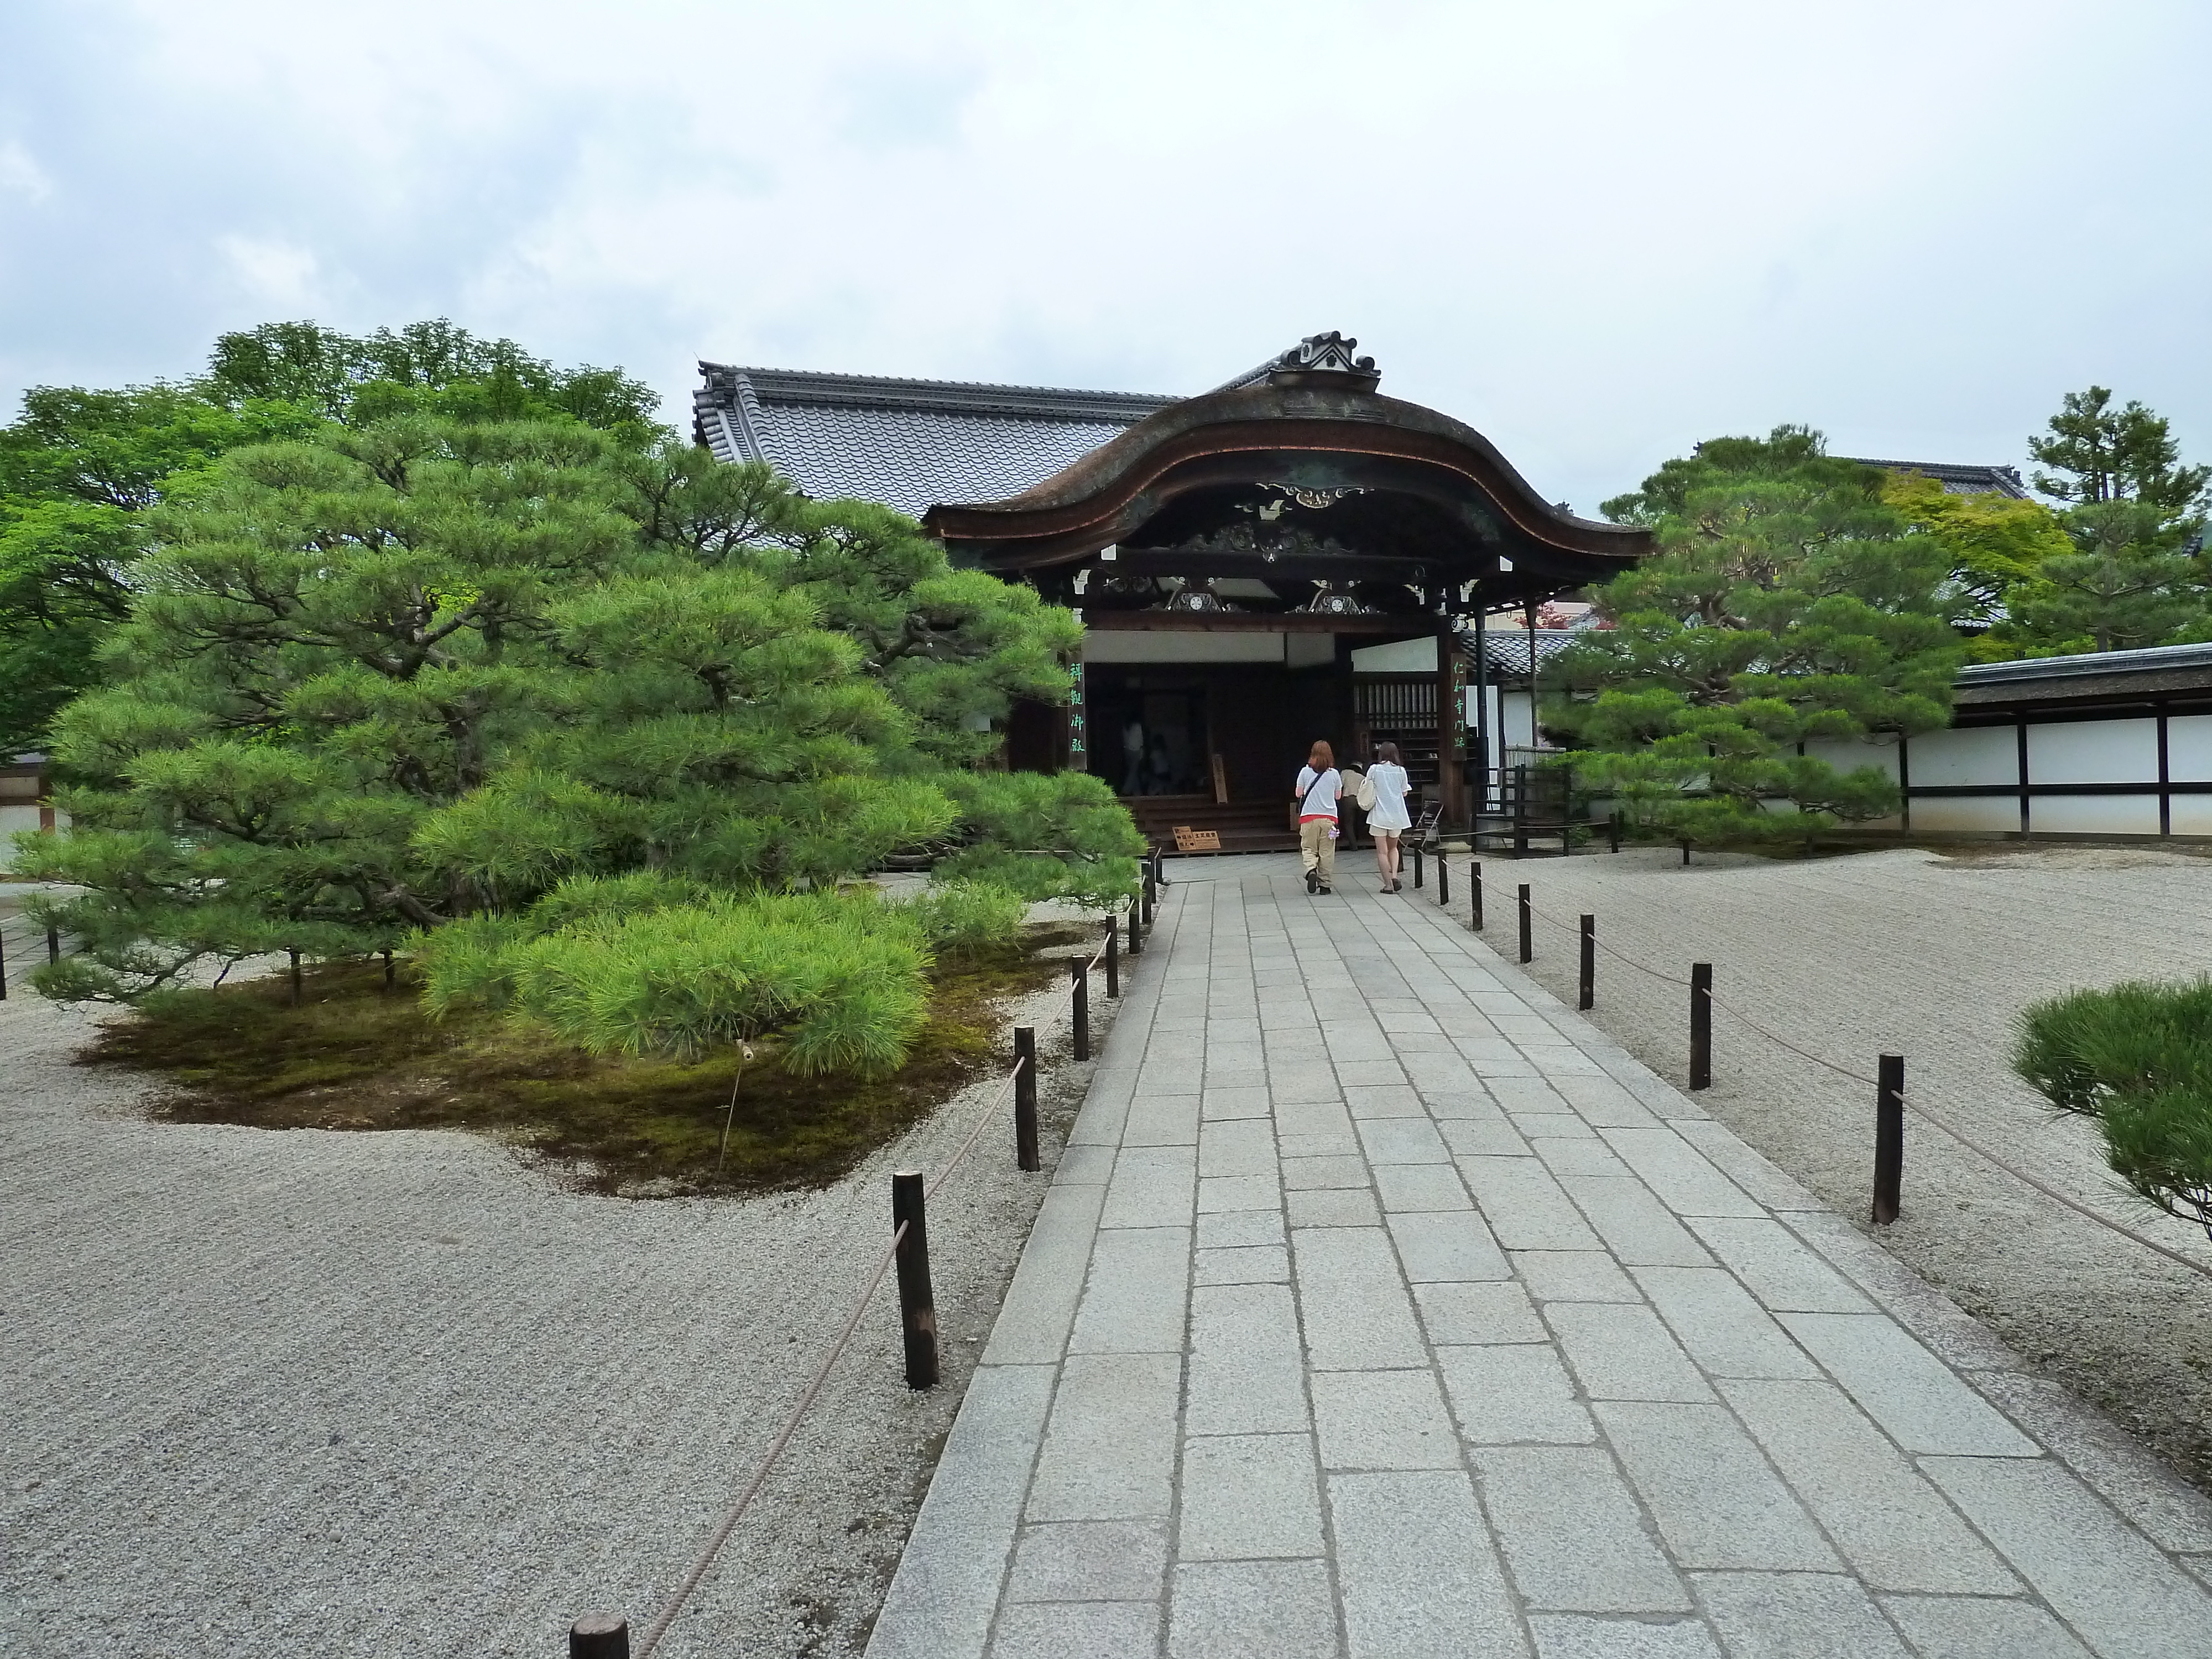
[[1544, 427, 1962, 841]]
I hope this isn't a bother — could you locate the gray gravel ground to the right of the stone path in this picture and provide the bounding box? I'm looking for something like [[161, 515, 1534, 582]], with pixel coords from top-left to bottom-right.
[[1451, 847, 2212, 1491]]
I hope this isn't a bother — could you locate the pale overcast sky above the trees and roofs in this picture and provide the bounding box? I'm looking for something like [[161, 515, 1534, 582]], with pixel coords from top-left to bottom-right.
[[0, 0, 2212, 511]]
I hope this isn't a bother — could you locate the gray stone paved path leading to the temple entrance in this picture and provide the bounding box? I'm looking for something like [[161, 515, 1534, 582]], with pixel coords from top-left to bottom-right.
[[869, 858, 2212, 1659]]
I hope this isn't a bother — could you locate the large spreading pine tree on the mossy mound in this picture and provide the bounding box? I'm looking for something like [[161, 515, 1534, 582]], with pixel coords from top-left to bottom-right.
[[22, 414, 1141, 1068]]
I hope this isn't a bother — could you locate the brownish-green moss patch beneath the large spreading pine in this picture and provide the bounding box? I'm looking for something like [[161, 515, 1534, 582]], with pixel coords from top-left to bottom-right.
[[84, 927, 1091, 1194]]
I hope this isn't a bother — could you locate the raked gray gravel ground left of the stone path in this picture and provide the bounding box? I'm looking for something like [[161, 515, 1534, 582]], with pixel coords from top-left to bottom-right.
[[0, 898, 1110, 1659]]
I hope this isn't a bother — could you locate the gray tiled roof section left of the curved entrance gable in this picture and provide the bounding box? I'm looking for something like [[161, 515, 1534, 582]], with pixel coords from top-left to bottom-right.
[[692, 363, 1175, 515]]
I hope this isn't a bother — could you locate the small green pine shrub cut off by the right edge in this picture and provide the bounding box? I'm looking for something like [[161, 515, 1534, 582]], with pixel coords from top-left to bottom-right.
[[2013, 978, 2212, 1237]]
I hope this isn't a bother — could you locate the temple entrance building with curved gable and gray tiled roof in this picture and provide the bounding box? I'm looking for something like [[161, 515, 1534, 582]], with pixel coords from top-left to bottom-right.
[[697, 334, 1650, 847]]
